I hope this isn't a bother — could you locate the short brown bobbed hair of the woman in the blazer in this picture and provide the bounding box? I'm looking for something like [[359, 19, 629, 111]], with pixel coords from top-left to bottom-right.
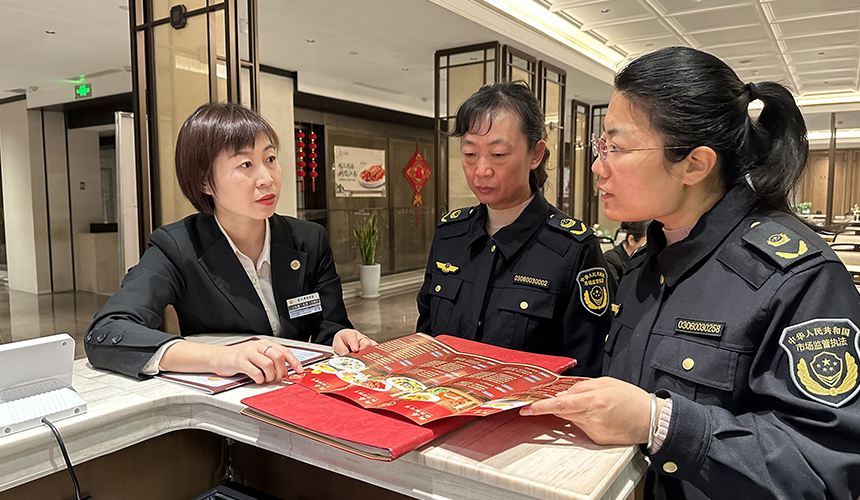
[[174, 102, 279, 215]]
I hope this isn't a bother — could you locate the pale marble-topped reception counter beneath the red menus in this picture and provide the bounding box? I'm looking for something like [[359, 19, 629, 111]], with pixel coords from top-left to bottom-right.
[[0, 336, 646, 500]]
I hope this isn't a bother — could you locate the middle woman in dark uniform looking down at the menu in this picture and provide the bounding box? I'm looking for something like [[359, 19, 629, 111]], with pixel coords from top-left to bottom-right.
[[416, 82, 609, 375]]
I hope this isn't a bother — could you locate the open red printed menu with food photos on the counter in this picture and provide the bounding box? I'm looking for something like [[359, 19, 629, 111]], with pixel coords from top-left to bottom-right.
[[288, 333, 585, 424]]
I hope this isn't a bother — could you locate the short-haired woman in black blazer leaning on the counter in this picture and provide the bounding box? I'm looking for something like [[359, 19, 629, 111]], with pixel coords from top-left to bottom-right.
[[85, 103, 374, 383]]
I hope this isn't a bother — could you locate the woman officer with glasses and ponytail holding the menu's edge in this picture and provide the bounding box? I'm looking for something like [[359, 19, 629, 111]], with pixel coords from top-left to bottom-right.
[[521, 47, 860, 500]]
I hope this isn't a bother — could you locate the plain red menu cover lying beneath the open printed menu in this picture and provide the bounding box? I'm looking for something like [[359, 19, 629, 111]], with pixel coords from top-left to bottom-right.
[[242, 335, 576, 461]]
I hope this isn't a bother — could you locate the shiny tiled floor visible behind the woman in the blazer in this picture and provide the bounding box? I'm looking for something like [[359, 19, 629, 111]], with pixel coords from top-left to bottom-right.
[[0, 280, 418, 359]]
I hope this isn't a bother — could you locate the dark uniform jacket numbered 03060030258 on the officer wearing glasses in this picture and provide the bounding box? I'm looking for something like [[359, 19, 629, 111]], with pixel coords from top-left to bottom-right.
[[604, 185, 860, 500]]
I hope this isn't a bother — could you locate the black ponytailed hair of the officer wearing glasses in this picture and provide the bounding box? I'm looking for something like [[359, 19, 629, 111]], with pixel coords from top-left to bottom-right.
[[615, 47, 809, 217]]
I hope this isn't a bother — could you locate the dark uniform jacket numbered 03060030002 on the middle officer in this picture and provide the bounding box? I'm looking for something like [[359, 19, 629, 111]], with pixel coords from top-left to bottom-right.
[[416, 192, 610, 376]]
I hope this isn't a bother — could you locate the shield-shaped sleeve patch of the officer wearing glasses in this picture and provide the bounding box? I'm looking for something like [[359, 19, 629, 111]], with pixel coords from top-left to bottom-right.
[[779, 318, 860, 408]]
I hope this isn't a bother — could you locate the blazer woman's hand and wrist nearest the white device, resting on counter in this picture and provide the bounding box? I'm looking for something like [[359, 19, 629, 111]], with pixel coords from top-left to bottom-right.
[[159, 340, 303, 384]]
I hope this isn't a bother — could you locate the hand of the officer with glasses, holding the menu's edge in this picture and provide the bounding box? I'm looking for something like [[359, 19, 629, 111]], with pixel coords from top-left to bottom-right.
[[520, 377, 663, 445]]
